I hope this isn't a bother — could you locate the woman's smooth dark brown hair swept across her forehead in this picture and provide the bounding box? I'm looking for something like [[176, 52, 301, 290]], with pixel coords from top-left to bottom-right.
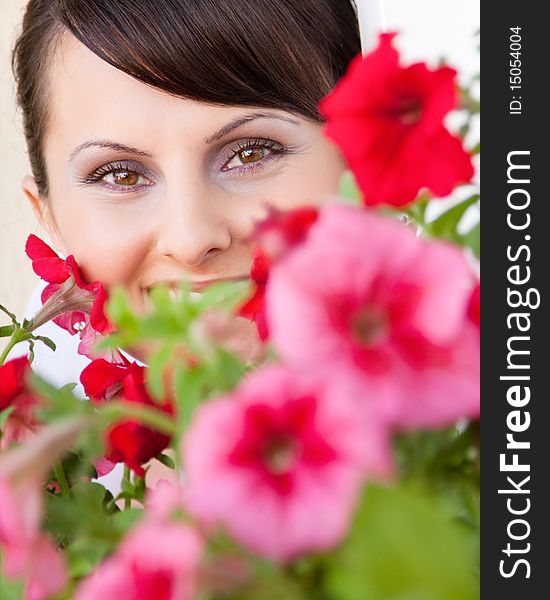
[[13, 0, 360, 195]]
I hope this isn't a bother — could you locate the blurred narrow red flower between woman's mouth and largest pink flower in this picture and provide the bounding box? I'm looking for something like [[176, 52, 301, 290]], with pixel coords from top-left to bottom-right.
[[238, 206, 319, 341]]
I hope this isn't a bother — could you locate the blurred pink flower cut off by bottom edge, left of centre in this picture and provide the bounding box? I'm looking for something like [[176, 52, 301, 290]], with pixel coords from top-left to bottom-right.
[[75, 520, 202, 600]]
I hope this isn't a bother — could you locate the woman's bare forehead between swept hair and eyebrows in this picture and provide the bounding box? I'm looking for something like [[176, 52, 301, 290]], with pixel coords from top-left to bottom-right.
[[45, 34, 294, 157]]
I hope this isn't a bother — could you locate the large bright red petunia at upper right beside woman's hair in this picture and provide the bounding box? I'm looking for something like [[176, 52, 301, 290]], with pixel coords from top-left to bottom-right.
[[319, 33, 474, 206]]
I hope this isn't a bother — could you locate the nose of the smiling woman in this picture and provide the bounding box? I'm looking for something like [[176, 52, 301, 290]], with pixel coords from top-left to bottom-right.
[[157, 181, 232, 267]]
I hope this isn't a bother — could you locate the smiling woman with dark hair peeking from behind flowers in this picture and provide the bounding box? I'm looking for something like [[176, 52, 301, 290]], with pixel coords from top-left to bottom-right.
[[14, 0, 360, 372]]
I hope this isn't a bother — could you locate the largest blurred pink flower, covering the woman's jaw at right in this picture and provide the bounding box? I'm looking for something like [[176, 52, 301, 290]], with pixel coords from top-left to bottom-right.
[[267, 205, 479, 428]]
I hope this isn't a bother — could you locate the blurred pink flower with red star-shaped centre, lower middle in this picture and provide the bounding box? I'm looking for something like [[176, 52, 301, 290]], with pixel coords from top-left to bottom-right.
[[182, 367, 390, 561]]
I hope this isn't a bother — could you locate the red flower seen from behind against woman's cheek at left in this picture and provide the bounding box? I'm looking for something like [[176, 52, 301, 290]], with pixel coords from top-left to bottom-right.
[[25, 235, 113, 358]]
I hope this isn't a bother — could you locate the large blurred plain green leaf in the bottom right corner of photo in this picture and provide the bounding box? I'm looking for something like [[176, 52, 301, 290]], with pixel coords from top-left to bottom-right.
[[329, 486, 479, 600]]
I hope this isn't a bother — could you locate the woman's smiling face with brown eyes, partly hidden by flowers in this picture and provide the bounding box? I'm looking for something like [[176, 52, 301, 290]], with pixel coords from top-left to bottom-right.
[[25, 35, 345, 356]]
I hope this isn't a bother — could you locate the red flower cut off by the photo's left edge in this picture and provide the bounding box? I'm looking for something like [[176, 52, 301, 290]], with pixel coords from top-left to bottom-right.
[[0, 356, 39, 449]]
